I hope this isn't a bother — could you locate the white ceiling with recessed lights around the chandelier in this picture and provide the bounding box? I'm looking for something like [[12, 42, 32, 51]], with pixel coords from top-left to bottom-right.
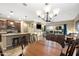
[[0, 3, 79, 21]]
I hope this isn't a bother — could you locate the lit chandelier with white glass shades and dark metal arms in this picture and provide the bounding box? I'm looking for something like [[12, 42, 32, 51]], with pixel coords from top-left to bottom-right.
[[36, 4, 60, 22]]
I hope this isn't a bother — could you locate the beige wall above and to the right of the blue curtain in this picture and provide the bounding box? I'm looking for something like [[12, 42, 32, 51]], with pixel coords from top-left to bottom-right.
[[47, 20, 75, 34]]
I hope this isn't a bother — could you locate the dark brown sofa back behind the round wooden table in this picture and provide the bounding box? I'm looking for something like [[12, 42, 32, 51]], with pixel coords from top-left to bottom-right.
[[46, 34, 65, 48]]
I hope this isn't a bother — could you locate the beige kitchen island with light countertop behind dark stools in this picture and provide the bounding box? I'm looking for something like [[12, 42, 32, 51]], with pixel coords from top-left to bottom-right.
[[1, 33, 27, 50]]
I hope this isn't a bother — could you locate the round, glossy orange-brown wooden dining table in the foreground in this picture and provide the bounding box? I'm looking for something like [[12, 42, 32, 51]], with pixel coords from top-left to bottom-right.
[[23, 40, 62, 56]]
